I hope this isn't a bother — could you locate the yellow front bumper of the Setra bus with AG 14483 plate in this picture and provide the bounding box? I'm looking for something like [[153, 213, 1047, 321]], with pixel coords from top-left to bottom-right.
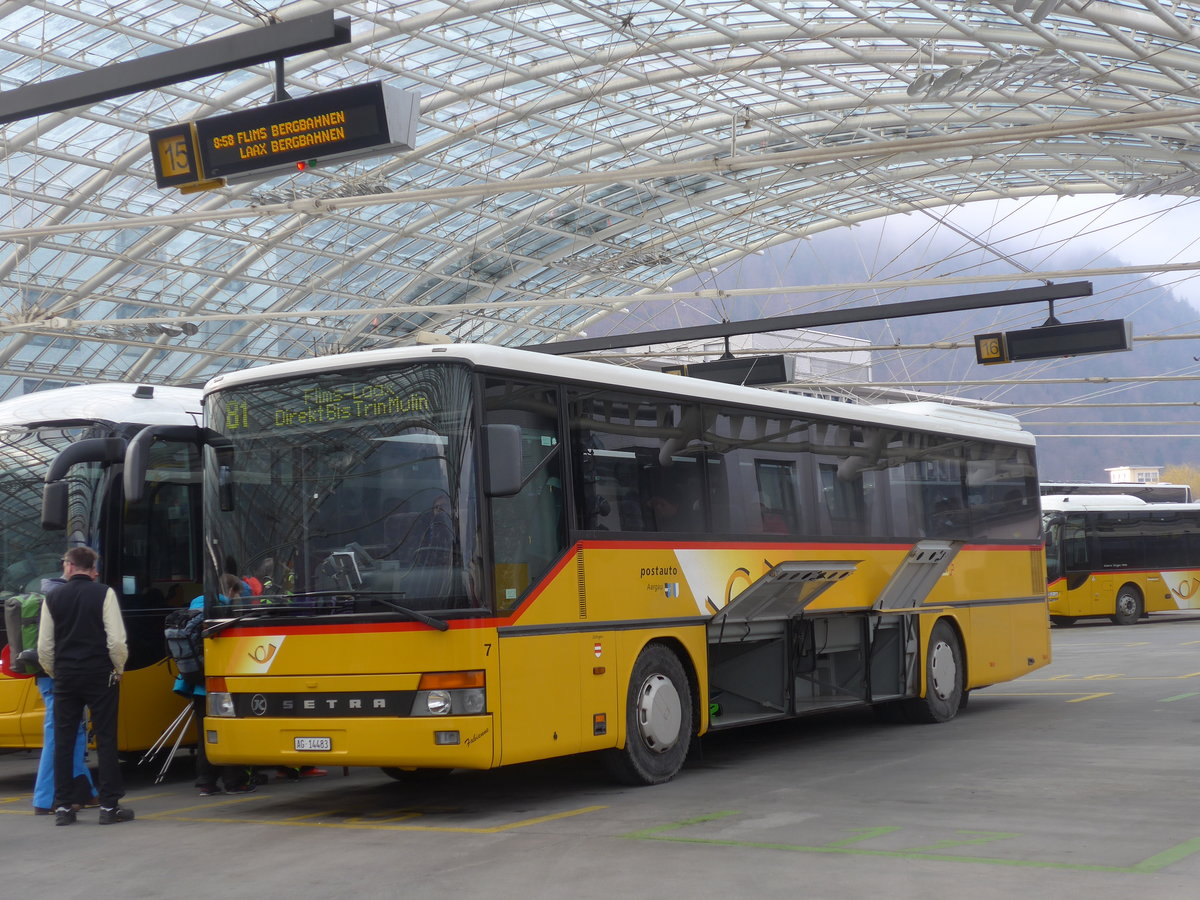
[[202, 715, 494, 769]]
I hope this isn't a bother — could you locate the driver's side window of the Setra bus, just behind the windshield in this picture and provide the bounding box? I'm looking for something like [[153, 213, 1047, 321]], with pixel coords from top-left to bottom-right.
[[484, 378, 566, 612]]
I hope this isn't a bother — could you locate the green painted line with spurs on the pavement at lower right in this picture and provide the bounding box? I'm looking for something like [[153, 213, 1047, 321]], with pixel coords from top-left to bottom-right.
[[622, 811, 1200, 875]]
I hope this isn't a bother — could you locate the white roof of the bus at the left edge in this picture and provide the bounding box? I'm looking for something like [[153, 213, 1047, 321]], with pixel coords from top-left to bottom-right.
[[0, 383, 203, 428]]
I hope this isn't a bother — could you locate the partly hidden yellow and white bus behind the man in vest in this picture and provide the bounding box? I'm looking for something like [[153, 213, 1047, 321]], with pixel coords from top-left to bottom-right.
[[0, 384, 202, 756]]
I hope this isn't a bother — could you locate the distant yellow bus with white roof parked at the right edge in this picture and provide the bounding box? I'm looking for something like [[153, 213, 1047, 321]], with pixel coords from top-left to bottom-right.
[[1042, 494, 1200, 625]]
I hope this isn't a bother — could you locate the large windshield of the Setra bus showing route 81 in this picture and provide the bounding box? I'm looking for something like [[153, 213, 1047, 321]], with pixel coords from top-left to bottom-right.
[[205, 365, 481, 618]]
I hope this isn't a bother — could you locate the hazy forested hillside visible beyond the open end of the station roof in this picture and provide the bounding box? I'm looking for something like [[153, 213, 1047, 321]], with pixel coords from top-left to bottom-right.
[[596, 220, 1200, 481]]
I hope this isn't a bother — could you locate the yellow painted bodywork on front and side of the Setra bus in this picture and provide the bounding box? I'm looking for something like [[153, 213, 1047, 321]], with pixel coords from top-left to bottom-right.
[[205, 541, 1051, 769]]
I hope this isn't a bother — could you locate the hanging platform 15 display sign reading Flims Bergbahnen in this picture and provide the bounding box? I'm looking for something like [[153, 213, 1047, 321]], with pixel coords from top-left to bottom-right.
[[150, 82, 420, 192]]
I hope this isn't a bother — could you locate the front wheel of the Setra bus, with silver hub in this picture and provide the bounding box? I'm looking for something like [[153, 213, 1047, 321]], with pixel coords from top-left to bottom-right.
[[607, 643, 692, 785]]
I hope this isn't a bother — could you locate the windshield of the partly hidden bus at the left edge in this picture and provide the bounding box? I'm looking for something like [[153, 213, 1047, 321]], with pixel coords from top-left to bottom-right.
[[0, 427, 100, 596]]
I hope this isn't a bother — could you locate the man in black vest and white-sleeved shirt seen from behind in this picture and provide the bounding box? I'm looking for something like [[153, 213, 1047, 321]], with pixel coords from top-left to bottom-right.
[[37, 547, 133, 826]]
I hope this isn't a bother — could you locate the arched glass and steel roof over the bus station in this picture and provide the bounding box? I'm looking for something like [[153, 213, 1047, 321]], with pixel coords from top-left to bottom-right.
[[0, 0, 1200, 396]]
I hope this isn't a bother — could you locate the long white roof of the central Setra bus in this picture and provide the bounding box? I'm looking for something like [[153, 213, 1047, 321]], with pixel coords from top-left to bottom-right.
[[204, 336, 1034, 446]]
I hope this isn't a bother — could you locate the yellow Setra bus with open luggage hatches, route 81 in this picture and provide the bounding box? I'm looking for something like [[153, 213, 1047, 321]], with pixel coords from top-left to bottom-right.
[[125, 344, 1050, 784]]
